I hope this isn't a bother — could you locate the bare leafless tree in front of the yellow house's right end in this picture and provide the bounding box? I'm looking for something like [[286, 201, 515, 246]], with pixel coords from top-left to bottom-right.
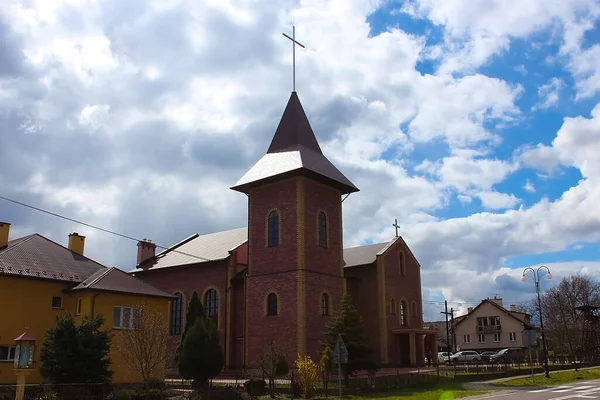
[[115, 302, 169, 382]]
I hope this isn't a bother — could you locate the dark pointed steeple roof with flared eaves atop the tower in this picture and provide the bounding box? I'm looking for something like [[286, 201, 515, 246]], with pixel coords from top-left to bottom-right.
[[231, 92, 358, 194]]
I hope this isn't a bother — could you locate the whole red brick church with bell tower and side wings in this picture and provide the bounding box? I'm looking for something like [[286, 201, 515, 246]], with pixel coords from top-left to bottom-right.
[[130, 92, 435, 373]]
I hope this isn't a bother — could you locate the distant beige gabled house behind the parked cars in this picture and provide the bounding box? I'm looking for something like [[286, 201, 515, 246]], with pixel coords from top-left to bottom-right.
[[455, 297, 535, 351]]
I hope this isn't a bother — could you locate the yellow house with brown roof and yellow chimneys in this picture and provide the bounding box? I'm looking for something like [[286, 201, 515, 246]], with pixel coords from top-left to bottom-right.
[[0, 222, 173, 384]]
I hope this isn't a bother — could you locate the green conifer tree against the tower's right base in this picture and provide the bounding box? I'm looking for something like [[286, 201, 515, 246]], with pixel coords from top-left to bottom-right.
[[325, 293, 375, 385]]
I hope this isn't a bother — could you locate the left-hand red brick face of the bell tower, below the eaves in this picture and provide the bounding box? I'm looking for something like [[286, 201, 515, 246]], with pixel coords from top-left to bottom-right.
[[246, 178, 298, 365]]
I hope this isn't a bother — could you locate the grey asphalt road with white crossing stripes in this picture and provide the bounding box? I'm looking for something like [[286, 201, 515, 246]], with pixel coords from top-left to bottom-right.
[[477, 381, 600, 400]]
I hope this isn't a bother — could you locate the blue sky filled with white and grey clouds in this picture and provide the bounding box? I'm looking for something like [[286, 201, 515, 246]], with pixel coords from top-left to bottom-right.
[[0, 0, 600, 318]]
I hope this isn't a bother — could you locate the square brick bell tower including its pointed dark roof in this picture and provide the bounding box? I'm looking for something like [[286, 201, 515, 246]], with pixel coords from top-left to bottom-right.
[[231, 91, 358, 366]]
